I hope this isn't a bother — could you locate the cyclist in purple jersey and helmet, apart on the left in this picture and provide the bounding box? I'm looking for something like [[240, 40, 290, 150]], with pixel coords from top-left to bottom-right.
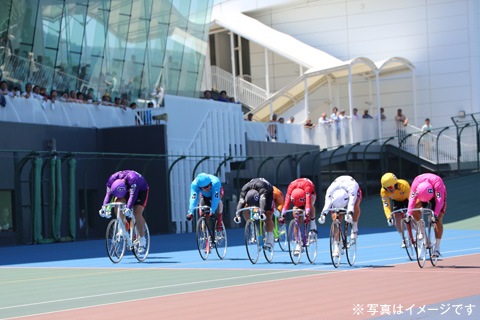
[[99, 170, 149, 250]]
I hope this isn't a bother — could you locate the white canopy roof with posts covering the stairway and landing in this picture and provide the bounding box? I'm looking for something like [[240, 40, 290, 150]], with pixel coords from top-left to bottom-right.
[[211, 12, 416, 135]]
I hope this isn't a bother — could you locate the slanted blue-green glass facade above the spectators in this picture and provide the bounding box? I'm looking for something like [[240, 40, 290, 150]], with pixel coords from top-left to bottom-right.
[[0, 0, 213, 101]]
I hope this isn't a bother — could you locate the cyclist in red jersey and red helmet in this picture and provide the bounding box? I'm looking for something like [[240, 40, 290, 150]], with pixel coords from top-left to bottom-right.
[[278, 178, 317, 252]]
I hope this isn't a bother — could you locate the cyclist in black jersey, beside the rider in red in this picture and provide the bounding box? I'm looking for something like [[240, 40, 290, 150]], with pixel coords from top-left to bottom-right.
[[237, 178, 274, 250]]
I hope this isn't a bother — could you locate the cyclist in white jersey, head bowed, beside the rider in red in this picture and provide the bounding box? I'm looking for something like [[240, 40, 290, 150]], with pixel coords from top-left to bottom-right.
[[318, 175, 362, 256]]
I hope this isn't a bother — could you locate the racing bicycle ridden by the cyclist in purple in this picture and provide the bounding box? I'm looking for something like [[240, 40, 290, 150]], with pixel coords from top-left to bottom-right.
[[103, 202, 150, 263]]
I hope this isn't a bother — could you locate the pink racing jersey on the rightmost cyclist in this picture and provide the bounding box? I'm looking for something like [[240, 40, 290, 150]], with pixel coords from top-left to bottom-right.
[[408, 173, 447, 216]]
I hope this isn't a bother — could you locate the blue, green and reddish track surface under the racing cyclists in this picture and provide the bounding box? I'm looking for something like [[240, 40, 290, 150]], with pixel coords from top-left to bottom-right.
[[0, 175, 480, 319]]
